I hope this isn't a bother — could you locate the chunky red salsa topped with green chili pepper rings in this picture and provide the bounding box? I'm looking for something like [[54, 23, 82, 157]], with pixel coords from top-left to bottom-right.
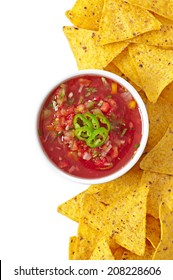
[[38, 75, 142, 179]]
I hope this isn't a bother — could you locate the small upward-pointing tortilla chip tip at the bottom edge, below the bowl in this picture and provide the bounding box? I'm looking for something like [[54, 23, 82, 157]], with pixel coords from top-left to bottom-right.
[[89, 238, 114, 260]]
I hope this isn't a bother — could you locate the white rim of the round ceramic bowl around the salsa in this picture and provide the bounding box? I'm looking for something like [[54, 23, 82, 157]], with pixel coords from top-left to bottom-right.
[[36, 70, 149, 185]]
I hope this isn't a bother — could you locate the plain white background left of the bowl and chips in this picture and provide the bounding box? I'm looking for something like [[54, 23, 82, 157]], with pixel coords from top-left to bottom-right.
[[0, 0, 171, 280]]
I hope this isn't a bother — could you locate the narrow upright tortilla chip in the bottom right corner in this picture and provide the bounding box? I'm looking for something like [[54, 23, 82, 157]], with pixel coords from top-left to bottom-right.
[[153, 203, 173, 260]]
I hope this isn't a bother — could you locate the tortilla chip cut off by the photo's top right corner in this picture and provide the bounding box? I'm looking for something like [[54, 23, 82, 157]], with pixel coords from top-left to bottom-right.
[[127, 0, 173, 20]]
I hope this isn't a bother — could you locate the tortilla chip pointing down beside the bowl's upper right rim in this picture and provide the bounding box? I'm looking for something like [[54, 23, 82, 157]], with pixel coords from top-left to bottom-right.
[[128, 44, 173, 103]]
